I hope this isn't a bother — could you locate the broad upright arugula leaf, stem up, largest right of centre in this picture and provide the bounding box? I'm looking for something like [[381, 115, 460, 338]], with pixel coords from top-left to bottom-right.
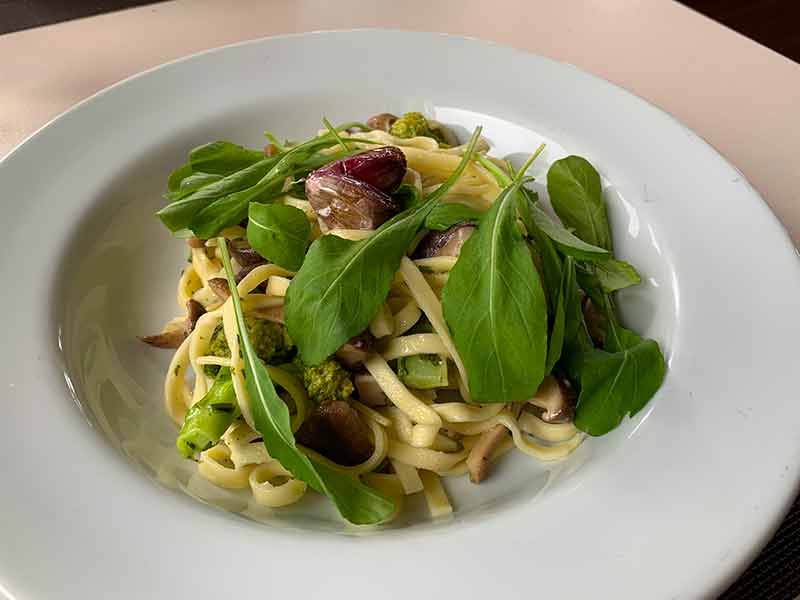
[[442, 163, 547, 403]]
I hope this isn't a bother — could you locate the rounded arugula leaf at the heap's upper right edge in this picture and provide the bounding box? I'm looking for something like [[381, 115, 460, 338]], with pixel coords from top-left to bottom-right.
[[547, 156, 613, 251]]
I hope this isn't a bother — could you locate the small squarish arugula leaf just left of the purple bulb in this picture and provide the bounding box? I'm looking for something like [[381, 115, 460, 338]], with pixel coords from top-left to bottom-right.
[[247, 202, 311, 271]]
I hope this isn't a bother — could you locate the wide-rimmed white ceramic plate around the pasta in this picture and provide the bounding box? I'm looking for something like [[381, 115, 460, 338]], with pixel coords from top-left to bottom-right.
[[0, 31, 800, 600]]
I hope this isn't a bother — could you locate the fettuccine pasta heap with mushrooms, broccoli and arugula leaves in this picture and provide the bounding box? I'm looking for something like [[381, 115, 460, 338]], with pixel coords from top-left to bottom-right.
[[142, 113, 665, 525]]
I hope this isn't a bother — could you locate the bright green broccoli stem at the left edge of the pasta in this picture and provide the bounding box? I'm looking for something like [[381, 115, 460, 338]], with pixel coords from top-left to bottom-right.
[[180, 369, 239, 458]]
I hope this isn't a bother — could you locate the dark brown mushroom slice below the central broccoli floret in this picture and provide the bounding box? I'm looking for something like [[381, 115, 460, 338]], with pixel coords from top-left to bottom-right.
[[295, 400, 373, 466]]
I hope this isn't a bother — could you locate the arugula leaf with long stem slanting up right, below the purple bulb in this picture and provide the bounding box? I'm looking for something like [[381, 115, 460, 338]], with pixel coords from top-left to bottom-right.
[[284, 127, 481, 365]]
